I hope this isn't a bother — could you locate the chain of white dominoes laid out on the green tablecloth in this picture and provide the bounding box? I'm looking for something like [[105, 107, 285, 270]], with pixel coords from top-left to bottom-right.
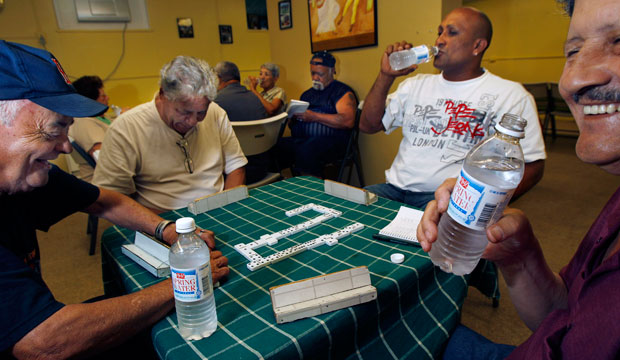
[[235, 203, 364, 271]]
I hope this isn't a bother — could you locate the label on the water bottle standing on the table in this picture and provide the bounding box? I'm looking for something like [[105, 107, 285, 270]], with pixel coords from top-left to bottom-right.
[[170, 262, 213, 302]]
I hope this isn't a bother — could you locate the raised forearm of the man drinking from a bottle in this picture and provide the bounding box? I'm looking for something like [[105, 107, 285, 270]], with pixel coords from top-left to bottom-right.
[[360, 72, 394, 134]]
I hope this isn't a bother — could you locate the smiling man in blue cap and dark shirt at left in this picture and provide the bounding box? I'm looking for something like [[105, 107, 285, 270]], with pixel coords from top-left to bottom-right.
[[0, 41, 228, 359]]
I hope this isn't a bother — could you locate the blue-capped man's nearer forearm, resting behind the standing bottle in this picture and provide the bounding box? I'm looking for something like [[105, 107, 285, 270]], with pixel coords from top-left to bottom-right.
[[13, 280, 174, 359]]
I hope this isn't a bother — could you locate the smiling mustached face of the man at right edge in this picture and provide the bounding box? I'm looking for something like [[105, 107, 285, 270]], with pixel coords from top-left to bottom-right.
[[560, 0, 620, 175]]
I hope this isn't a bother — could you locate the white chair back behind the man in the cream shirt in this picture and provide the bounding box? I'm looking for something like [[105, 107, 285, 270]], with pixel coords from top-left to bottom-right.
[[230, 112, 288, 189]]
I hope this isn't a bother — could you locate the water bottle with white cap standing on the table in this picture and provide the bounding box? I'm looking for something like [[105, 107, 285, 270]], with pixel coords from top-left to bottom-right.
[[169, 217, 217, 340]]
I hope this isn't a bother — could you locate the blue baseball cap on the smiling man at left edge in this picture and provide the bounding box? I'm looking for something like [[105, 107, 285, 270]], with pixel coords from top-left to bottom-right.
[[0, 40, 108, 117]]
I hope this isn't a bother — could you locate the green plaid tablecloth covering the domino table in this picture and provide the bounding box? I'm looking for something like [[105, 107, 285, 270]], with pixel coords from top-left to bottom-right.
[[101, 177, 494, 360]]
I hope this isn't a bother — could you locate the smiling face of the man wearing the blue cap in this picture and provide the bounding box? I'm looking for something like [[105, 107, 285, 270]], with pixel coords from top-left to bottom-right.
[[0, 101, 73, 194]]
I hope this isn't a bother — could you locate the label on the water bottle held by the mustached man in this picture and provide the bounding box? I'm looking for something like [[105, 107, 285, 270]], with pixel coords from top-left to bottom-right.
[[448, 169, 514, 230]]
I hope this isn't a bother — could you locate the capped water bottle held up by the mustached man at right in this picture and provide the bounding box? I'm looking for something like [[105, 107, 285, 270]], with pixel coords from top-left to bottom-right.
[[429, 114, 527, 275]]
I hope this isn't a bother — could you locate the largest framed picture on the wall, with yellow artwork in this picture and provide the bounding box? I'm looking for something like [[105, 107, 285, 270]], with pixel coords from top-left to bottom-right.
[[308, 0, 377, 52]]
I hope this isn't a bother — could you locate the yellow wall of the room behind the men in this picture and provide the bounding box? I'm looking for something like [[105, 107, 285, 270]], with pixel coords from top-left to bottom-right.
[[0, 0, 568, 184]]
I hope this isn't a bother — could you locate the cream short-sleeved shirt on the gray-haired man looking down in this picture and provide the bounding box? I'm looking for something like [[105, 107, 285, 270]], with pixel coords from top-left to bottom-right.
[[93, 100, 247, 210]]
